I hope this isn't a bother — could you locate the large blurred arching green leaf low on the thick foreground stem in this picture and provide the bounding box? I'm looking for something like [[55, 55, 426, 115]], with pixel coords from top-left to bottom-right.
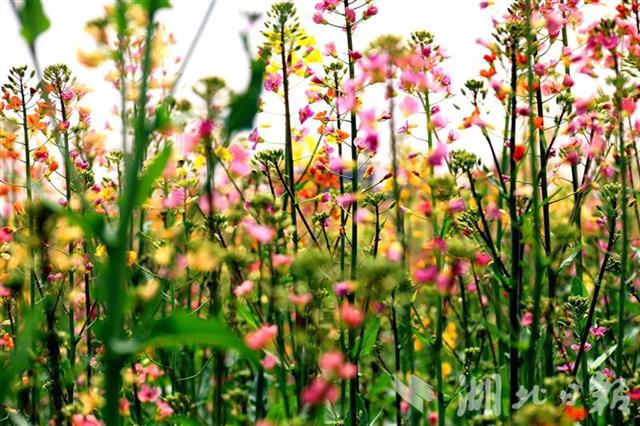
[[114, 313, 258, 363]]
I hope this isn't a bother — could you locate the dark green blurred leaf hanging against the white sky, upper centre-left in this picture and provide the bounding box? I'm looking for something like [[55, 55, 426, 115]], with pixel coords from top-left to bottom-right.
[[225, 59, 265, 136]]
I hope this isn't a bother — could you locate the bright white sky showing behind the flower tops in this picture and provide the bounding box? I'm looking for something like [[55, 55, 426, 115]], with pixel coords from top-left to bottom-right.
[[0, 0, 620, 160]]
